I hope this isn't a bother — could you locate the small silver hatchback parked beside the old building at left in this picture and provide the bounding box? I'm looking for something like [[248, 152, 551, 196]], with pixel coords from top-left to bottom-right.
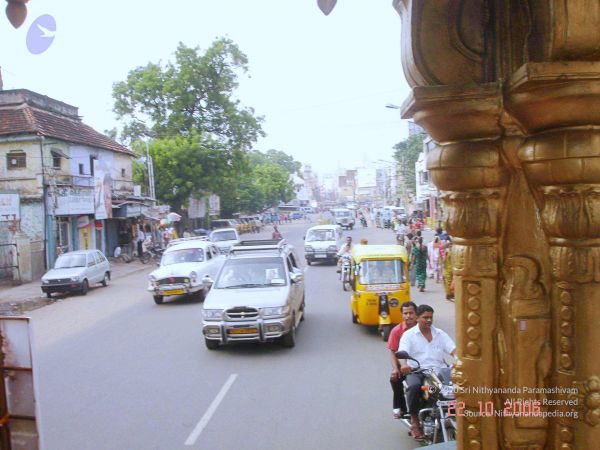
[[42, 250, 110, 298]]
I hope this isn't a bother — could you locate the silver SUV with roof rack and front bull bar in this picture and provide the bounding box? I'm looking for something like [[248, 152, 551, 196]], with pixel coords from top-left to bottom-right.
[[202, 240, 305, 350]]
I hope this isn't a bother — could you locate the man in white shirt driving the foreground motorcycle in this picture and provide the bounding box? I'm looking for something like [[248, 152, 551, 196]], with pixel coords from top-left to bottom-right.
[[398, 305, 456, 440]]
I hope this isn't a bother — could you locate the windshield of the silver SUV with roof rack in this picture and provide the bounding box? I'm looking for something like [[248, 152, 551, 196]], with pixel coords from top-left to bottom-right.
[[215, 257, 286, 289]]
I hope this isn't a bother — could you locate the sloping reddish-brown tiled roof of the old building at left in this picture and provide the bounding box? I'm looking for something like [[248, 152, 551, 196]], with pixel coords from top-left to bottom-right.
[[0, 105, 135, 155]]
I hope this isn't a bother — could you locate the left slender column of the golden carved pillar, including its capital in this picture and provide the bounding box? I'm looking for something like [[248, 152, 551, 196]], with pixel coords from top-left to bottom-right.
[[406, 84, 507, 449]]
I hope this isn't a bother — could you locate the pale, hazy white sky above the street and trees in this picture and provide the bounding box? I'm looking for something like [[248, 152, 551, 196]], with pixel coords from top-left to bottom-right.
[[0, 0, 409, 179]]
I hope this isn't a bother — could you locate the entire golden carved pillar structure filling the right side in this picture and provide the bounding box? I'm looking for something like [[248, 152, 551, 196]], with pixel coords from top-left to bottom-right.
[[393, 0, 600, 450]]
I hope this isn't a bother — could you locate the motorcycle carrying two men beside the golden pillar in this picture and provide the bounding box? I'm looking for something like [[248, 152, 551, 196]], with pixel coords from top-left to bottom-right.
[[396, 351, 457, 445]]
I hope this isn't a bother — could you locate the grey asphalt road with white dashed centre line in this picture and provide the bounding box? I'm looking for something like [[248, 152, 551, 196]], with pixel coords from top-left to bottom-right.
[[31, 217, 454, 450]]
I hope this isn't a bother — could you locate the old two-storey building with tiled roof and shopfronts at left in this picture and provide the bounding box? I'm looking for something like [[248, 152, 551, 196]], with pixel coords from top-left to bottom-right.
[[0, 89, 142, 280]]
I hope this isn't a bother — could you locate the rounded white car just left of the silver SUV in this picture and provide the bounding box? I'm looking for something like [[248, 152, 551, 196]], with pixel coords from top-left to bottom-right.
[[148, 236, 225, 305]]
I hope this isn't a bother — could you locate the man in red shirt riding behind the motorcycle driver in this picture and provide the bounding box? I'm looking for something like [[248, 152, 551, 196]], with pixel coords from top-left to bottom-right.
[[387, 302, 417, 419]]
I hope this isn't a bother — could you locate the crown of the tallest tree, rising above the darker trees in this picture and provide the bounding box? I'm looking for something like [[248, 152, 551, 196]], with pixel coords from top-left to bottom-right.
[[113, 38, 264, 150]]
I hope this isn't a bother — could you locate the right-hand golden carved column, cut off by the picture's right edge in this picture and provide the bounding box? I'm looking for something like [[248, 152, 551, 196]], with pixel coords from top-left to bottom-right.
[[507, 62, 600, 449]]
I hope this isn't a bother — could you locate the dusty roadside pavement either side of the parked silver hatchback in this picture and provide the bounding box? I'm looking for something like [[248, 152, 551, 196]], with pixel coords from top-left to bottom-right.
[[0, 258, 155, 316]]
